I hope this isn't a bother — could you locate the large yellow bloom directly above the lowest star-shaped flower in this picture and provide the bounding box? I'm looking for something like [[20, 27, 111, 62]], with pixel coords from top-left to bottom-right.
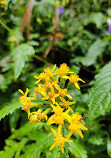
[[47, 103, 70, 125]]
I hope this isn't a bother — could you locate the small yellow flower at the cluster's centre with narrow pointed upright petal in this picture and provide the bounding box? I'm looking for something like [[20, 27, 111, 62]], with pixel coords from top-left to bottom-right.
[[41, 87, 59, 104]]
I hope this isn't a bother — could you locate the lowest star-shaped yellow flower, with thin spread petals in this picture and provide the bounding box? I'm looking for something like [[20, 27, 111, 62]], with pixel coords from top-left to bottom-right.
[[49, 126, 72, 153]]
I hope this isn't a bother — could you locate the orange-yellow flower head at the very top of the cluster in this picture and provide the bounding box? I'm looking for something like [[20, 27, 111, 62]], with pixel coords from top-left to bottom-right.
[[55, 63, 73, 77]]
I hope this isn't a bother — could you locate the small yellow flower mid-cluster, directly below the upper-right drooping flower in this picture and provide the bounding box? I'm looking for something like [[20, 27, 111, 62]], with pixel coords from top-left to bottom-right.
[[55, 84, 72, 99]]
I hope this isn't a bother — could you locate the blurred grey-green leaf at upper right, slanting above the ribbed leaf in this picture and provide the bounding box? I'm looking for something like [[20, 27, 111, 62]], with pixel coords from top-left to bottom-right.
[[74, 39, 107, 66]]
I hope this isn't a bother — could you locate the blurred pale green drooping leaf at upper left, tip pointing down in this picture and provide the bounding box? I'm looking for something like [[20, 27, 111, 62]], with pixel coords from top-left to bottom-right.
[[12, 44, 35, 79]]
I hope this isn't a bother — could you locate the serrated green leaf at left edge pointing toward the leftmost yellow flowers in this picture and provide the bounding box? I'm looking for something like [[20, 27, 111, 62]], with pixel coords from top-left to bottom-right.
[[0, 101, 22, 120]]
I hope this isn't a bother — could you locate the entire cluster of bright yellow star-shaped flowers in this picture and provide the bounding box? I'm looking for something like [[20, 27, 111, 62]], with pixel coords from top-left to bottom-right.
[[19, 63, 87, 153]]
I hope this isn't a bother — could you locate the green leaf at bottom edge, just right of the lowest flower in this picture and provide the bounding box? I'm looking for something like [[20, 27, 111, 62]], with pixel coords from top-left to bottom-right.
[[69, 139, 87, 158]]
